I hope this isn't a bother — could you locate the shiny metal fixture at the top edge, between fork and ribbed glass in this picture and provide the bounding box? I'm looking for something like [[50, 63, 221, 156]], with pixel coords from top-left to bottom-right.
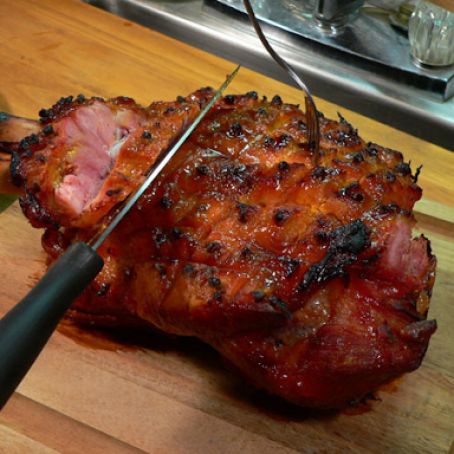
[[314, 0, 364, 33]]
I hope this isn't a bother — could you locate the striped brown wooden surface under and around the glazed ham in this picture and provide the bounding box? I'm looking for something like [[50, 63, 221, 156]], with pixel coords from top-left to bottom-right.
[[0, 0, 454, 454]]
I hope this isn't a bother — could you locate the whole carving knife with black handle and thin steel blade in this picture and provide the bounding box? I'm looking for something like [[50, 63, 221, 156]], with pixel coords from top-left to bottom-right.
[[0, 65, 241, 409]]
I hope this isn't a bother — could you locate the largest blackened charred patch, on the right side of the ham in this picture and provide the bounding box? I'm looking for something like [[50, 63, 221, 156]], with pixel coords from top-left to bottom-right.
[[299, 219, 370, 290]]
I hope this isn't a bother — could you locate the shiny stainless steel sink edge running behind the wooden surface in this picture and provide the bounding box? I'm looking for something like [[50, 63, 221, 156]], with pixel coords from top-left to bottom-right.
[[84, 0, 454, 151]]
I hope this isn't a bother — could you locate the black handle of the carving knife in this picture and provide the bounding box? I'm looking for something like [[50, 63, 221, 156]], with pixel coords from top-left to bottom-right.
[[0, 243, 104, 409]]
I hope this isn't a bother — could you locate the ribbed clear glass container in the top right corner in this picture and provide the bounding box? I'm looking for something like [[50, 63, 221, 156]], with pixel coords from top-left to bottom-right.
[[408, 0, 454, 66]]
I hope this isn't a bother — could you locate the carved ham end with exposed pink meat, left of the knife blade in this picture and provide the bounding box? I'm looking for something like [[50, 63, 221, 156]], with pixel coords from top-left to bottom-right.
[[12, 96, 199, 228]]
